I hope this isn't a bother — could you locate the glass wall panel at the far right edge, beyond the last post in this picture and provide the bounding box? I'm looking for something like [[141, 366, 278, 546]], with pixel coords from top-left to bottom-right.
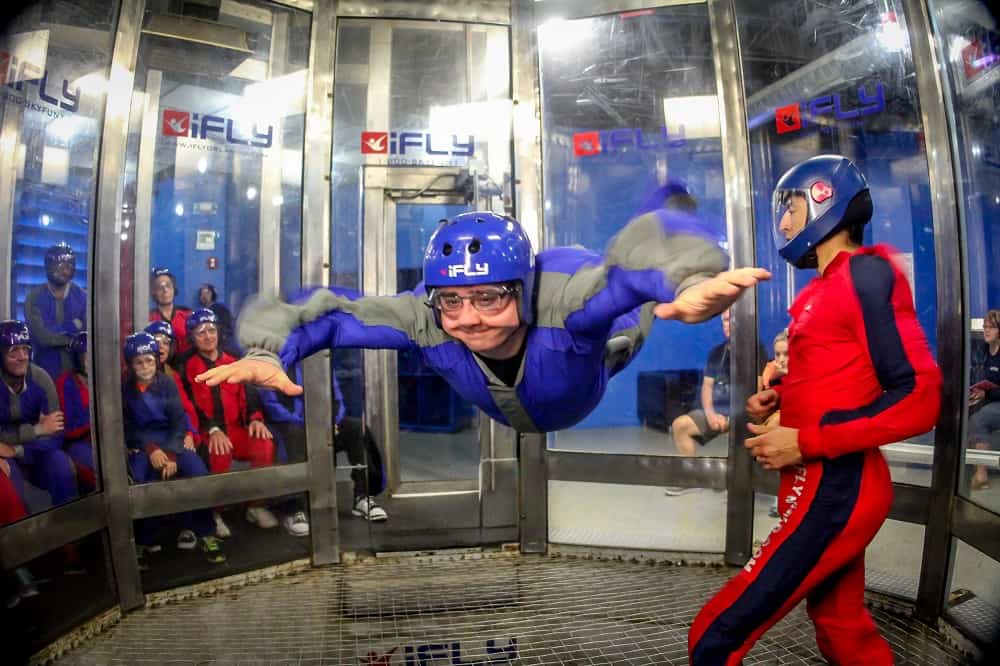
[[930, 0, 1000, 511]]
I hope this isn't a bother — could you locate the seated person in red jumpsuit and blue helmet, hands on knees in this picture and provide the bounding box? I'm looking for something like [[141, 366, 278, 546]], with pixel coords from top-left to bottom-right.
[[181, 308, 278, 532]]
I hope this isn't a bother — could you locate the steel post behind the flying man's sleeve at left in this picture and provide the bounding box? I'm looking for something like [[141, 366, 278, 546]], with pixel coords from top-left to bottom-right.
[[302, 1, 340, 565]]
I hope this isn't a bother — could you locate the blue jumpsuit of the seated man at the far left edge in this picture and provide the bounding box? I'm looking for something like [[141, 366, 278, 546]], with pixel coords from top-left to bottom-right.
[[0, 363, 77, 504]]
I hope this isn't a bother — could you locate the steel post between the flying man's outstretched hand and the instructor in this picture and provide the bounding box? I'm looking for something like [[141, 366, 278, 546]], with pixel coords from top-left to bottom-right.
[[708, 0, 760, 565]]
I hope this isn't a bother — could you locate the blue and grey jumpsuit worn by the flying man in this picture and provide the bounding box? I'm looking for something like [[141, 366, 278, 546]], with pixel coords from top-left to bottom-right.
[[239, 209, 728, 432]]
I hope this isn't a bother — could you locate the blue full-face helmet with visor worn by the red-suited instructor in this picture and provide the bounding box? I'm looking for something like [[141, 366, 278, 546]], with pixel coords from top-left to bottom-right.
[[773, 155, 872, 268]]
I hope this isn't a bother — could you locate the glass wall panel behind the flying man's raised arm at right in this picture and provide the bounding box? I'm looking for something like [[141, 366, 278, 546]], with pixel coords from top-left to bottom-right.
[[538, 5, 729, 455]]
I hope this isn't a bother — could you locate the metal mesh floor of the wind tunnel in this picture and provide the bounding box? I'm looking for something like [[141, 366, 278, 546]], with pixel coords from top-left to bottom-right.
[[59, 555, 962, 666]]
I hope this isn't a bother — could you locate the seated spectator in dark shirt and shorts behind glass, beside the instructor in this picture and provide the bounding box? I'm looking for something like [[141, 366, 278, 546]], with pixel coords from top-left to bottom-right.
[[670, 310, 767, 456]]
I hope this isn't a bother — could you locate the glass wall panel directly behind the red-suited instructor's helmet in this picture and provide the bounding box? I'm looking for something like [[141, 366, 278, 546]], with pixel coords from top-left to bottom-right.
[[735, 0, 937, 485]]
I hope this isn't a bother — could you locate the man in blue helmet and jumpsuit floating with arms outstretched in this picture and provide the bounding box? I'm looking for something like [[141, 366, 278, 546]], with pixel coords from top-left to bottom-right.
[[200, 202, 770, 432]]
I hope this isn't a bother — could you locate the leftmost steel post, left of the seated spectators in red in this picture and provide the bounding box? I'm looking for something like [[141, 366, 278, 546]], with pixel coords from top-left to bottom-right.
[[90, 2, 145, 610]]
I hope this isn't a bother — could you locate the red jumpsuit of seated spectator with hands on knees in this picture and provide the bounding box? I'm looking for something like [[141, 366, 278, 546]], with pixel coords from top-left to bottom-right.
[[182, 352, 274, 474]]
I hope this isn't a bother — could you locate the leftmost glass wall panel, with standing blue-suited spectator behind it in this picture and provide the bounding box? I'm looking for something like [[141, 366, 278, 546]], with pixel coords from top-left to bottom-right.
[[0, 0, 118, 522]]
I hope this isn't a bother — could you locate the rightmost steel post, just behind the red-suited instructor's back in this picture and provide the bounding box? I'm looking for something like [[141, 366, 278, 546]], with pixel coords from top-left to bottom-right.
[[903, 0, 969, 621]]
